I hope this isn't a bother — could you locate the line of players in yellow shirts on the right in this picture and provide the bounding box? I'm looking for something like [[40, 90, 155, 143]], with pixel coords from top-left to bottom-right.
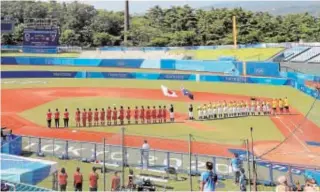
[[195, 98, 289, 119]]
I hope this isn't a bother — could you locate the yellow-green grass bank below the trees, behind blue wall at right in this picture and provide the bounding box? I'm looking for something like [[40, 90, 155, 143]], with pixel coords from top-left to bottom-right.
[[170, 48, 283, 61]]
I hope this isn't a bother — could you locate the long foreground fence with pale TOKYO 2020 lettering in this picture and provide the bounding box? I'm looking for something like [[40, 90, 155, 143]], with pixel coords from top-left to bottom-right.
[[22, 133, 320, 189]]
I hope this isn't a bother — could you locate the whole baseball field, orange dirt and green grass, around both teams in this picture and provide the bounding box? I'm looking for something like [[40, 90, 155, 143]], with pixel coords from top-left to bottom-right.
[[1, 65, 320, 190]]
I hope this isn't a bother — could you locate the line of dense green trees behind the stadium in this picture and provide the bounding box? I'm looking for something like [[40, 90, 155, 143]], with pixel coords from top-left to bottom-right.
[[1, 1, 320, 47]]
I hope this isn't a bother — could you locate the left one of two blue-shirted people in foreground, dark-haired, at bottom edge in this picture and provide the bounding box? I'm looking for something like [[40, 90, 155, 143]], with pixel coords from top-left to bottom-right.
[[200, 162, 218, 191]]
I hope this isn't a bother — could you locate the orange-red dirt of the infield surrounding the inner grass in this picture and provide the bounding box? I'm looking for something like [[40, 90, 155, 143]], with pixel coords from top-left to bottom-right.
[[1, 88, 320, 165]]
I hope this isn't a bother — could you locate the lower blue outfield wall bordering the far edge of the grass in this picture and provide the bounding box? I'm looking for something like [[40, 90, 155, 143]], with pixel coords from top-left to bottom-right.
[[1, 71, 320, 99]]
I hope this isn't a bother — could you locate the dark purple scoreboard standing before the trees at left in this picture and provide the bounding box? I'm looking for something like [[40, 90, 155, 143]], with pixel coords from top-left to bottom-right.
[[23, 28, 59, 47]]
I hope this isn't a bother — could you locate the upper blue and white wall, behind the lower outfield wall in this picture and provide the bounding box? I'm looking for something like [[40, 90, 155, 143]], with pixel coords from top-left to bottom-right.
[[1, 57, 279, 77]]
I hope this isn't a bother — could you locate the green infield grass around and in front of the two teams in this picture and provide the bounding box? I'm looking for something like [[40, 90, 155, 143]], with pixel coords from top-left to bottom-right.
[[20, 97, 283, 145]]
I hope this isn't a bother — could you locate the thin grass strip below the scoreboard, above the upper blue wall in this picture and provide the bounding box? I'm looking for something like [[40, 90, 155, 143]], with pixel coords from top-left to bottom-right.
[[1, 52, 80, 57]]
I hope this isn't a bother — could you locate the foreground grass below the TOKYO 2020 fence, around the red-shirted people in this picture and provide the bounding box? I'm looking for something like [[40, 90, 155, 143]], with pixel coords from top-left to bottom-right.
[[31, 155, 274, 191]]
